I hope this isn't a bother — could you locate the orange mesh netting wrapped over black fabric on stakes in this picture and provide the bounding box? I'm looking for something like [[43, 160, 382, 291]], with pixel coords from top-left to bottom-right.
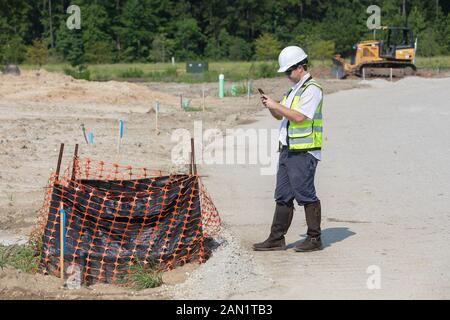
[[34, 159, 220, 284]]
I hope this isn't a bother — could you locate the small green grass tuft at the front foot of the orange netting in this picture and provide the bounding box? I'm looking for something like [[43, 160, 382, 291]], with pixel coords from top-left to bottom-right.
[[122, 261, 163, 290]]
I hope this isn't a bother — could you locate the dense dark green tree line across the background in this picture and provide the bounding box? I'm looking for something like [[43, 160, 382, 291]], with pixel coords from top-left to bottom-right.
[[0, 0, 450, 65]]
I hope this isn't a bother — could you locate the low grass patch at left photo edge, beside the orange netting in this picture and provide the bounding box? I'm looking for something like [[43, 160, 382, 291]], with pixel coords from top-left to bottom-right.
[[0, 245, 40, 273]]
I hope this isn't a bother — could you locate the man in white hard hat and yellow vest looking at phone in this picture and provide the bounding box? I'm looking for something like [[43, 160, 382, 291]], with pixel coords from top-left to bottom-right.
[[253, 46, 323, 252]]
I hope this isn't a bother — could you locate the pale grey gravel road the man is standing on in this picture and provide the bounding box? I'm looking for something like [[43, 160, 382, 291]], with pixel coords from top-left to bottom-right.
[[178, 77, 450, 299]]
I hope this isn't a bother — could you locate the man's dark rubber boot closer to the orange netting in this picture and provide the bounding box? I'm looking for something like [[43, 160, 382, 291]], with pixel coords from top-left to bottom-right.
[[253, 203, 294, 251]]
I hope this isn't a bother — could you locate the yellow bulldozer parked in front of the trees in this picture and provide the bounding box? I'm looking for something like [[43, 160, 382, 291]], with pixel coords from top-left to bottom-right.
[[332, 27, 417, 79]]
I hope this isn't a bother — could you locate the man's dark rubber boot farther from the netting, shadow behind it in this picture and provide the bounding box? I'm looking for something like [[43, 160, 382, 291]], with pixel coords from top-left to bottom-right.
[[294, 201, 322, 252]]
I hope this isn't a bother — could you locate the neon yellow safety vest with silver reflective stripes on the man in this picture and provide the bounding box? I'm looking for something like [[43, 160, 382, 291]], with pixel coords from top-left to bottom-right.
[[281, 78, 323, 151]]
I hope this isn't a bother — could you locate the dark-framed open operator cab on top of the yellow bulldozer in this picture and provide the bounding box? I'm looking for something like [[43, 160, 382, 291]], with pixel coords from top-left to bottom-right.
[[380, 27, 414, 59]]
